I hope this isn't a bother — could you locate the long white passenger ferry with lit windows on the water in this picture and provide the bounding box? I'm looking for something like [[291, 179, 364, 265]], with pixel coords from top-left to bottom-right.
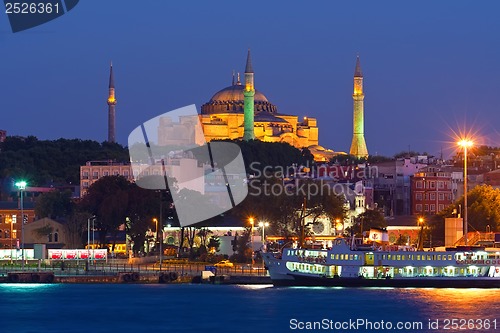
[[263, 238, 500, 288]]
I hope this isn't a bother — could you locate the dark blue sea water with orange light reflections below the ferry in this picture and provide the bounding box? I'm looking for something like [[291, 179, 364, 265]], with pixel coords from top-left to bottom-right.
[[0, 284, 500, 333]]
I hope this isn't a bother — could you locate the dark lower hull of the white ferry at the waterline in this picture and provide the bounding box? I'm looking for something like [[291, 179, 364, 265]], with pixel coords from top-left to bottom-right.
[[273, 274, 500, 288]]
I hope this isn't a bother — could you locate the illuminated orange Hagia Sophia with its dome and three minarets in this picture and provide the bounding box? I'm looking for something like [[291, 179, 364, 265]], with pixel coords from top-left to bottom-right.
[[112, 50, 368, 162]]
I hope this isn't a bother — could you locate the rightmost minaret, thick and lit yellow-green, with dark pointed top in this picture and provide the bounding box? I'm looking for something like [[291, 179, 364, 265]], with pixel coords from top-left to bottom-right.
[[349, 56, 368, 158]]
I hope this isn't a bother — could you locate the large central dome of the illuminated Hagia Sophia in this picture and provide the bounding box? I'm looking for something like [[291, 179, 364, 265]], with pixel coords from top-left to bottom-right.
[[201, 82, 277, 114]]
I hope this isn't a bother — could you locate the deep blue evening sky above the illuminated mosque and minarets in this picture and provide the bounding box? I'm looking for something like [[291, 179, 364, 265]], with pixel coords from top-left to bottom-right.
[[0, 0, 500, 155]]
